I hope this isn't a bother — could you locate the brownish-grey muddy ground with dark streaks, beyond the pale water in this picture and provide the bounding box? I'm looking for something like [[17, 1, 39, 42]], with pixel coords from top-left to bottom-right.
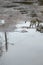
[[0, 2, 43, 31]]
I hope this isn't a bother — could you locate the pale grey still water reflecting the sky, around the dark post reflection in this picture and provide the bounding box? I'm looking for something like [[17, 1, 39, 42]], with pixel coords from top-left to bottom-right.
[[0, 23, 43, 65]]
